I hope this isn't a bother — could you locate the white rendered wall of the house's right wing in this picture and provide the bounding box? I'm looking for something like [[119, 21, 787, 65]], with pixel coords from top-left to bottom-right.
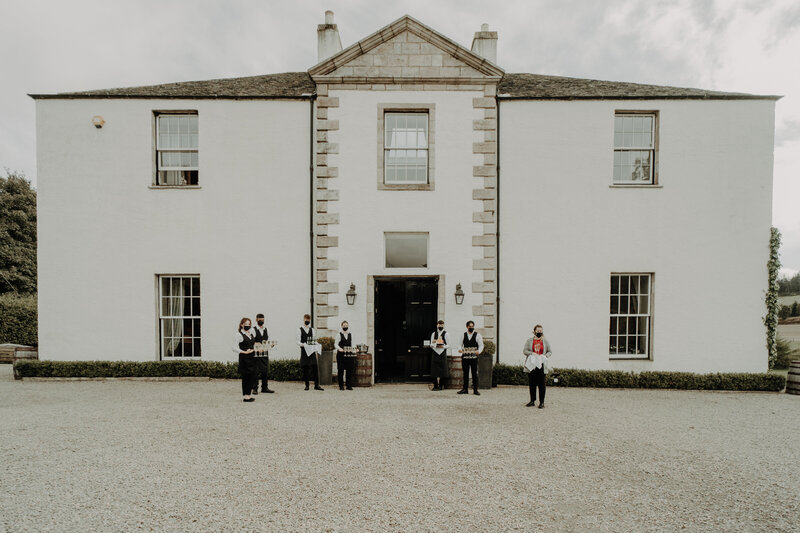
[[499, 100, 774, 372]]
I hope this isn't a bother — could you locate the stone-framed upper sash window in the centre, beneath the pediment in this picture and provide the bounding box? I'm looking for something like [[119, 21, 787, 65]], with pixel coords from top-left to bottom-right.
[[378, 103, 436, 191]]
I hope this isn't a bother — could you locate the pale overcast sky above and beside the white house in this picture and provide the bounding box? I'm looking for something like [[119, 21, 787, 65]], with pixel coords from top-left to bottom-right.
[[0, 0, 800, 270]]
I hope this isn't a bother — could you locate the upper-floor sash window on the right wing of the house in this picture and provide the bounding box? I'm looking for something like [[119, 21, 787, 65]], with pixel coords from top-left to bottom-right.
[[614, 111, 658, 185]]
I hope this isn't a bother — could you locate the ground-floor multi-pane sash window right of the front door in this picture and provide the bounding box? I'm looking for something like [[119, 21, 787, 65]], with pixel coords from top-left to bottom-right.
[[608, 274, 653, 359]]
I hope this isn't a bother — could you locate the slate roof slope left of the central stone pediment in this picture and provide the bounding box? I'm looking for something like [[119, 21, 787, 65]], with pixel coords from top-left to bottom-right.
[[30, 72, 316, 100]]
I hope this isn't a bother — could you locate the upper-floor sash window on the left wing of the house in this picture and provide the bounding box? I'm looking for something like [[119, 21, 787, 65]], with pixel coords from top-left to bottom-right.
[[156, 113, 198, 185]]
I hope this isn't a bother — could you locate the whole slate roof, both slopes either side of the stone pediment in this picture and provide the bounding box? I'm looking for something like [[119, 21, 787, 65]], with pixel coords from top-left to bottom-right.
[[30, 72, 781, 100]]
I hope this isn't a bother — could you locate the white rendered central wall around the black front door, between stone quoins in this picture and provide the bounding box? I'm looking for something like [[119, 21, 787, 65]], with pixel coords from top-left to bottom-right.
[[328, 90, 483, 349]]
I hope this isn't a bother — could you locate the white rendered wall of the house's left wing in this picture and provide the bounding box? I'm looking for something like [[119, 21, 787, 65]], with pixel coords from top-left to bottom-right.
[[37, 99, 310, 361]]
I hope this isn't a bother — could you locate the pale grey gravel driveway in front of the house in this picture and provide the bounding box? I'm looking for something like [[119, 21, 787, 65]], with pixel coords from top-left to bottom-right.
[[0, 365, 800, 532]]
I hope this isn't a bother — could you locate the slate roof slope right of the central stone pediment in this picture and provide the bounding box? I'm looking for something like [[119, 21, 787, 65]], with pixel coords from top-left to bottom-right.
[[497, 73, 781, 100]]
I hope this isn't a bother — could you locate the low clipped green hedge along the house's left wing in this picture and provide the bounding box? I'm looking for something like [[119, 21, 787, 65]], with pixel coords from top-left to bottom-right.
[[14, 359, 303, 381]]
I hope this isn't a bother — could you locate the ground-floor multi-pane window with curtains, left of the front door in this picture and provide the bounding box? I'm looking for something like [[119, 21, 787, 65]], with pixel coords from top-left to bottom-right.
[[158, 275, 201, 359]]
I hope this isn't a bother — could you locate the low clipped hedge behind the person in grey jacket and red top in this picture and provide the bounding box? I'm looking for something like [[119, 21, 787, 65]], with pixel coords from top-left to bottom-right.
[[492, 364, 786, 392]]
